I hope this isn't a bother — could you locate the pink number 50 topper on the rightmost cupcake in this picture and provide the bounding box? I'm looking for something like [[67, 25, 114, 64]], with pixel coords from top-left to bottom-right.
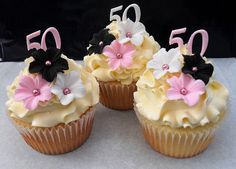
[[169, 28, 209, 56]]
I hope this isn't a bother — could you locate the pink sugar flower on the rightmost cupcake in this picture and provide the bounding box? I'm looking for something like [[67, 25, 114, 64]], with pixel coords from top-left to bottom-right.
[[167, 73, 205, 106]]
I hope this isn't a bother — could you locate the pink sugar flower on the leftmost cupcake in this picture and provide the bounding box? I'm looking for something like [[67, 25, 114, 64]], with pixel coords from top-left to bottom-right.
[[15, 75, 52, 110]]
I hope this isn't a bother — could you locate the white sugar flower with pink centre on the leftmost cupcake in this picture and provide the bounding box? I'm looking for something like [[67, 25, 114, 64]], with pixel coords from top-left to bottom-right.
[[51, 71, 86, 105]]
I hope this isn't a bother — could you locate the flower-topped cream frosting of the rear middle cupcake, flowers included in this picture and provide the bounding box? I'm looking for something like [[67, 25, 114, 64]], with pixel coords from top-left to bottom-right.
[[84, 19, 160, 85]]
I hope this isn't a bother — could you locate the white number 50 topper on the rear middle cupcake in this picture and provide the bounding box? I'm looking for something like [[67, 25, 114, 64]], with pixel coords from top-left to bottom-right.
[[110, 4, 141, 22]]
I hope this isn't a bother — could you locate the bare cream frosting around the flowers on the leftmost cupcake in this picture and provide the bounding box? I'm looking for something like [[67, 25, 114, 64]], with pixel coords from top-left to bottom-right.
[[6, 55, 99, 127]]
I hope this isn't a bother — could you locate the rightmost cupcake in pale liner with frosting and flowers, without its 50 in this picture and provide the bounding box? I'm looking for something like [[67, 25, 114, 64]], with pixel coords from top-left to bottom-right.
[[134, 30, 229, 158]]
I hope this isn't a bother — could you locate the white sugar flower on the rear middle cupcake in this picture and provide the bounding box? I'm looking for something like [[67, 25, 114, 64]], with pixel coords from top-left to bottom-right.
[[118, 19, 146, 46]]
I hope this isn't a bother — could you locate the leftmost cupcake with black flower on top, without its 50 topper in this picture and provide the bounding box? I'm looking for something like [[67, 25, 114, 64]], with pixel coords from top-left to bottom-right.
[[6, 27, 99, 155]]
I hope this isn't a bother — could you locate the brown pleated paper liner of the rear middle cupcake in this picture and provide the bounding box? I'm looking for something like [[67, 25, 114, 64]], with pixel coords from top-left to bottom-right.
[[98, 81, 137, 110]]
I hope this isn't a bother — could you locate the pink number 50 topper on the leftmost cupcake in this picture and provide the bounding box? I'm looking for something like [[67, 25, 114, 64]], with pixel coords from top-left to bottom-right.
[[26, 27, 61, 51]]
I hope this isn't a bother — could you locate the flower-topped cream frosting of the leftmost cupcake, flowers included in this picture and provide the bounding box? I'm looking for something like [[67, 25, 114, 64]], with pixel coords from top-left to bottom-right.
[[6, 49, 99, 127]]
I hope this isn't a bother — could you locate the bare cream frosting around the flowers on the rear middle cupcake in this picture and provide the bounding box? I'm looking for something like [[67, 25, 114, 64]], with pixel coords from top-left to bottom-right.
[[84, 21, 160, 85]]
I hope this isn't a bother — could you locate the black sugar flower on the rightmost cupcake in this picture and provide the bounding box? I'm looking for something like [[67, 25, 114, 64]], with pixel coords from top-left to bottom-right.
[[182, 54, 214, 84]]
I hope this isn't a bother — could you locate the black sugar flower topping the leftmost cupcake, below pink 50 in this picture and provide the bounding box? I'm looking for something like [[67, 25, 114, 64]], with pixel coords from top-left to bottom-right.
[[29, 48, 69, 82]]
